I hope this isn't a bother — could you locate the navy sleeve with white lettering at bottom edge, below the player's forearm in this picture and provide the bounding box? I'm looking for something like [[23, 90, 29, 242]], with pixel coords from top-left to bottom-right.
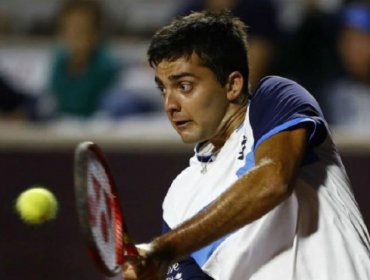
[[162, 222, 213, 280]]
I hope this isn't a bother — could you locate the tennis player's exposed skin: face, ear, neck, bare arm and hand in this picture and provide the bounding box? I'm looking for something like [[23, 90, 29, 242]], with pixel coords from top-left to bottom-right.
[[123, 55, 307, 280]]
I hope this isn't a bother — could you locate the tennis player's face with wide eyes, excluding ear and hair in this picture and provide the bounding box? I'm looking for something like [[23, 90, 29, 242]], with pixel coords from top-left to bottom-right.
[[155, 54, 230, 143]]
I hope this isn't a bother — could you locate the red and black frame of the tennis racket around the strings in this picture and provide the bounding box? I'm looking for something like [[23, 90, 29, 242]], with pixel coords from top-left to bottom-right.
[[74, 141, 139, 276]]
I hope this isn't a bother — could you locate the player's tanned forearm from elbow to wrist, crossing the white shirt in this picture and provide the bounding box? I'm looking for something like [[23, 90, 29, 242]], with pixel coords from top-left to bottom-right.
[[147, 160, 288, 261]]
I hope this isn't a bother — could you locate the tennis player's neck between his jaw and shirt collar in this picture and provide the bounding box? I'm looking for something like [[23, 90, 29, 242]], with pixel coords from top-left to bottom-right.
[[209, 100, 247, 151]]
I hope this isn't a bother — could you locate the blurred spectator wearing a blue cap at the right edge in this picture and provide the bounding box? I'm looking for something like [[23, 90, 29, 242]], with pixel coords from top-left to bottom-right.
[[321, 3, 370, 131]]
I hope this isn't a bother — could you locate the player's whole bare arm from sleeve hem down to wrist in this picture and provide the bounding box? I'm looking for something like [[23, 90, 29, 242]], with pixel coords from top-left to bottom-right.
[[123, 127, 307, 279]]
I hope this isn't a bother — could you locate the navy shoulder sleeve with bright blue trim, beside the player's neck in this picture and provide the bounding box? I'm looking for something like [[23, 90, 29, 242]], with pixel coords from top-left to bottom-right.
[[249, 76, 327, 150]]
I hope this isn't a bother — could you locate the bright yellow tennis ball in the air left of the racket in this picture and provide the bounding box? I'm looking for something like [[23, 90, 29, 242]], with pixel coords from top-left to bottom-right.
[[15, 187, 58, 224]]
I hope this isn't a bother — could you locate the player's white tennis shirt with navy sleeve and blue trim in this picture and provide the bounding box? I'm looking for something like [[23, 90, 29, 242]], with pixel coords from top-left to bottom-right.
[[163, 76, 370, 280]]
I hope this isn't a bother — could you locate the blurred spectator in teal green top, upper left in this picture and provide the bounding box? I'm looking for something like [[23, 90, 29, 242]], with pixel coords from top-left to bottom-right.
[[43, 0, 121, 118]]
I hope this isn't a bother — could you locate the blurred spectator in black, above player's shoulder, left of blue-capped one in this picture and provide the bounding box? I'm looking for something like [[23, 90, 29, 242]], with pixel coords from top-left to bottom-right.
[[276, 0, 342, 95]]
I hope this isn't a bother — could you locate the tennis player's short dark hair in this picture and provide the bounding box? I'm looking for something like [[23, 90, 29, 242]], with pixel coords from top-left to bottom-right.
[[147, 10, 249, 95]]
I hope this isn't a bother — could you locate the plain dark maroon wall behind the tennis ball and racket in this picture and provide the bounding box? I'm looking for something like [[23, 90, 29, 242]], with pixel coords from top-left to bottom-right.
[[0, 149, 370, 280]]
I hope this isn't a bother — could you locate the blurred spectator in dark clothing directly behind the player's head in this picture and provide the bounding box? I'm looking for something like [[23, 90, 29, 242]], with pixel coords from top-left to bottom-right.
[[178, 0, 279, 89]]
